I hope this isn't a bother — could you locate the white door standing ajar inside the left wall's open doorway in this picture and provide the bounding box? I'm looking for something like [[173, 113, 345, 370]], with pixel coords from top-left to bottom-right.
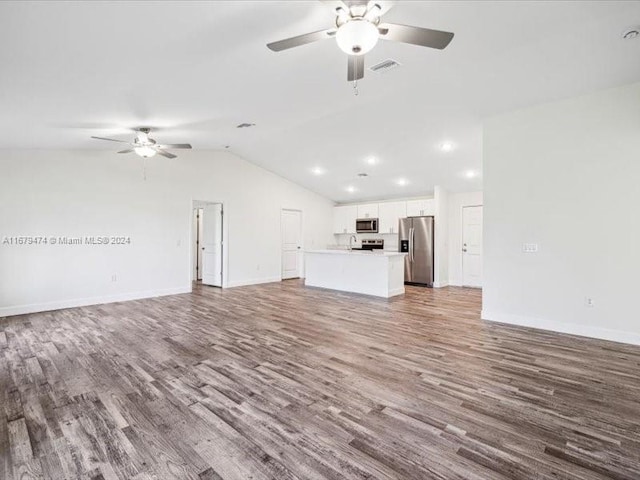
[[200, 203, 222, 287]]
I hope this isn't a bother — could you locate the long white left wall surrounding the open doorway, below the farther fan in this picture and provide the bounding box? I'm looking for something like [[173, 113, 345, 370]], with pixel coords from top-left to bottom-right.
[[0, 151, 333, 316]]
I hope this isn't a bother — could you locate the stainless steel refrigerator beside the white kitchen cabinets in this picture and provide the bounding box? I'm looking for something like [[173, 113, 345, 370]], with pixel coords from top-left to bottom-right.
[[398, 217, 434, 287]]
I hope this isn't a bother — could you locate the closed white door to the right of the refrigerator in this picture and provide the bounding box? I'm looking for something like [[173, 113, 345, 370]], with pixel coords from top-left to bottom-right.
[[462, 206, 482, 287]]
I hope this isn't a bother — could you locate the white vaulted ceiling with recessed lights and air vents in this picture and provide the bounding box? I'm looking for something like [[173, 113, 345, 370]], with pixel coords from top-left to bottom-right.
[[0, 0, 640, 201]]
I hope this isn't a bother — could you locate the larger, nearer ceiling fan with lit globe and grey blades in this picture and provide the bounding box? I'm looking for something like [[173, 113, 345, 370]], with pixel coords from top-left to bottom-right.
[[267, 0, 453, 82]]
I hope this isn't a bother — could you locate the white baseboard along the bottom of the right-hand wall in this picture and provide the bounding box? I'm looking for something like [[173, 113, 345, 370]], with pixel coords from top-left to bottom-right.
[[481, 310, 640, 345]]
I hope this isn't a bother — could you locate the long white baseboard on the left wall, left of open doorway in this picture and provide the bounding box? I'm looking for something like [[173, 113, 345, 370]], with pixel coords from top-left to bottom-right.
[[0, 284, 191, 317]]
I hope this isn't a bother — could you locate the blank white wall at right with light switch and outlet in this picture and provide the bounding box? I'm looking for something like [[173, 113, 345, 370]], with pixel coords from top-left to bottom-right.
[[483, 84, 640, 344]]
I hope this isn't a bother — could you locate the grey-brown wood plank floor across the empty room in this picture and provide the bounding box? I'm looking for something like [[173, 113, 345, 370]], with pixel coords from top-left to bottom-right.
[[0, 281, 640, 480]]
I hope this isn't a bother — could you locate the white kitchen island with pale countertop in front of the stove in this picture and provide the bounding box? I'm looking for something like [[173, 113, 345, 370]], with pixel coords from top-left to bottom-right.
[[305, 250, 406, 298]]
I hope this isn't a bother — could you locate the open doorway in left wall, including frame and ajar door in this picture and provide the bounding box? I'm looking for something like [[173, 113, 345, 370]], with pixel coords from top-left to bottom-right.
[[191, 202, 224, 287]]
